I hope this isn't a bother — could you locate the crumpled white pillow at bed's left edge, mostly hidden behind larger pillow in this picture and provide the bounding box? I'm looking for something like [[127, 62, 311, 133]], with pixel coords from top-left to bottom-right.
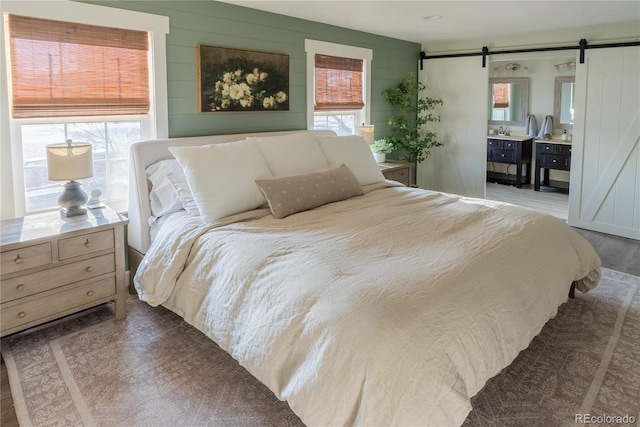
[[146, 159, 184, 218]]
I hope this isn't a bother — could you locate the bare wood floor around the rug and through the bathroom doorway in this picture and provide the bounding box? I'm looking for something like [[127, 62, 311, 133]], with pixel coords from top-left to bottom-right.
[[0, 183, 640, 427]]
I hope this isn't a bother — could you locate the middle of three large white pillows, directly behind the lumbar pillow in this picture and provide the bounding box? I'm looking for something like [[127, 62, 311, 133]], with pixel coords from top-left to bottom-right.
[[257, 132, 329, 178]]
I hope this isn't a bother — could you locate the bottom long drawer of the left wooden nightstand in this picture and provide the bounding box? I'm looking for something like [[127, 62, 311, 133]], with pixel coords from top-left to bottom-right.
[[0, 277, 116, 330]]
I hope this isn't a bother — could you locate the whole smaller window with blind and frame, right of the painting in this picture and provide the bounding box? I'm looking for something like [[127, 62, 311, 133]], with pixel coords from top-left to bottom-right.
[[305, 40, 372, 135]]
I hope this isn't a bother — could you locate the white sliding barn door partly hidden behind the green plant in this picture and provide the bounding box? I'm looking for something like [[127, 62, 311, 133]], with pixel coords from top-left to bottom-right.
[[416, 56, 489, 198]]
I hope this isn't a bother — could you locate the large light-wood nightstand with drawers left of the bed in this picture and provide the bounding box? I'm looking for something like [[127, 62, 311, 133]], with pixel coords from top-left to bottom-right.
[[0, 207, 128, 336]]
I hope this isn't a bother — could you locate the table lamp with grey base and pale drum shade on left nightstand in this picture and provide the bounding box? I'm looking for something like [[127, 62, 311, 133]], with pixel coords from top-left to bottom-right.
[[47, 139, 93, 217]]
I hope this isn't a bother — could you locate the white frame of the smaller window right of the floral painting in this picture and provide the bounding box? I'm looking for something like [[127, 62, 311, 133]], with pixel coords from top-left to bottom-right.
[[304, 39, 373, 134]]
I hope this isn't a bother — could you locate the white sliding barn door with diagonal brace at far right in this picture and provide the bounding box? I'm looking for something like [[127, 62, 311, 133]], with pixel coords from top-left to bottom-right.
[[569, 47, 640, 239]]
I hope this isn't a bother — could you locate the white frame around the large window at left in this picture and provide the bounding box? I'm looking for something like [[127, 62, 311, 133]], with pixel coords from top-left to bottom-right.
[[0, 0, 169, 218]]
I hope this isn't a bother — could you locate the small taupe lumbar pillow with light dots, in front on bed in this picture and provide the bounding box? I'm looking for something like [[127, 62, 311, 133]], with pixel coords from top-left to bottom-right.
[[256, 165, 362, 219]]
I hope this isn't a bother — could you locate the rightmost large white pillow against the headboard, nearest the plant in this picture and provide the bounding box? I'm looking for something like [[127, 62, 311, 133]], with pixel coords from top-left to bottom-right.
[[318, 135, 384, 185]]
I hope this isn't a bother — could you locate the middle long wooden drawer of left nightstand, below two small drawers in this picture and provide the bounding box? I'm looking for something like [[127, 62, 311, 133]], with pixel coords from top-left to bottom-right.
[[2, 254, 116, 303]]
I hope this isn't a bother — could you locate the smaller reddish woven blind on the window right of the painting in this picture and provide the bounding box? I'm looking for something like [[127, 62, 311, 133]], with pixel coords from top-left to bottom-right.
[[314, 54, 364, 111]]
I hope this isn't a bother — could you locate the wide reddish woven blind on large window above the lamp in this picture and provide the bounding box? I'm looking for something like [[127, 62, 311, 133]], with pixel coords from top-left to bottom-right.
[[8, 15, 149, 118]]
